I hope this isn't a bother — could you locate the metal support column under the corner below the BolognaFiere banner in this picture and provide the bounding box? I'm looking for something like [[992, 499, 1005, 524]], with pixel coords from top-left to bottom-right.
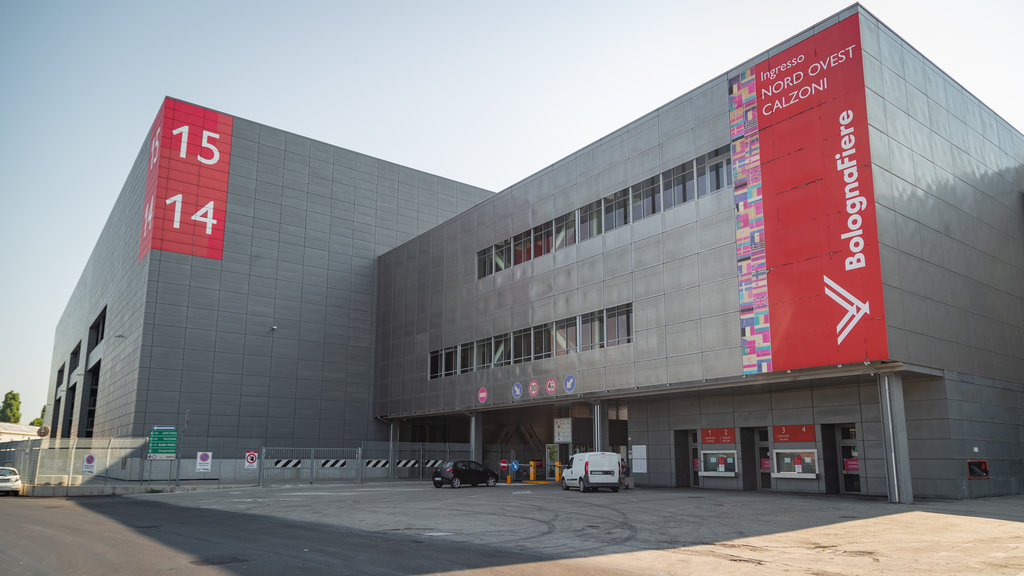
[[876, 372, 913, 504]]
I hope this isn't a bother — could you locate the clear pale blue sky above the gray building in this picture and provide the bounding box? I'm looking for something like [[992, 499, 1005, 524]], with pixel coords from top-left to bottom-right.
[[0, 0, 1024, 423]]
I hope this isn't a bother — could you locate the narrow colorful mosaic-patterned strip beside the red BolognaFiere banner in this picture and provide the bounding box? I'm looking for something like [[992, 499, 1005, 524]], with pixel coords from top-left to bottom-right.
[[729, 68, 772, 374]]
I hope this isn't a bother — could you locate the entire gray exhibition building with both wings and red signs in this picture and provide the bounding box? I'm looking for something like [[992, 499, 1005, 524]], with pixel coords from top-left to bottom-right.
[[47, 5, 1024, 502]]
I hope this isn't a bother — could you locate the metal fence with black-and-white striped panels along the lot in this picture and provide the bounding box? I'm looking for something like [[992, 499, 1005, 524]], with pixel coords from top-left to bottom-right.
[[0, 437, 544, 488]]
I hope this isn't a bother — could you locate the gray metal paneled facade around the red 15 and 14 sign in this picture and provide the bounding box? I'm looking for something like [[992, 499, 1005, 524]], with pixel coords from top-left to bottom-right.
[[47, 106, 493, 446]]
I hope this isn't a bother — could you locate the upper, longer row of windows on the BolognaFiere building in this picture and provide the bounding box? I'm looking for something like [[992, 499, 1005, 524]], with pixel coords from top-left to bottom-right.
[[476, 146, 732, 279]]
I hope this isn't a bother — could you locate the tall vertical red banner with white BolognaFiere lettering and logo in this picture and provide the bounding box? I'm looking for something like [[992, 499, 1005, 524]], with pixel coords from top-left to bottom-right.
[[754, 15, 889, 370]]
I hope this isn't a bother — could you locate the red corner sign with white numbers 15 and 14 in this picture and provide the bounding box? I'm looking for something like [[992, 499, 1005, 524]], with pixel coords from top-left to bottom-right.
[[138, 98, 233, 260]]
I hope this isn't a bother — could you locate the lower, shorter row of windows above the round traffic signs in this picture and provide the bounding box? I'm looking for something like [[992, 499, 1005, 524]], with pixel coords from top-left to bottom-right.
[[430, 303, 633, 379]]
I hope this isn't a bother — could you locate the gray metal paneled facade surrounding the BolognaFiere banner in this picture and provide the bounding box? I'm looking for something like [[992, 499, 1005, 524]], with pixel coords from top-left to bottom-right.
[[375, 5, 1024, 501]]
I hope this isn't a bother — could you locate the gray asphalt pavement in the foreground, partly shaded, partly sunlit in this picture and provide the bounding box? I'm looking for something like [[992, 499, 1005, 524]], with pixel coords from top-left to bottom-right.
[[0, 482, 1024, 576]]
